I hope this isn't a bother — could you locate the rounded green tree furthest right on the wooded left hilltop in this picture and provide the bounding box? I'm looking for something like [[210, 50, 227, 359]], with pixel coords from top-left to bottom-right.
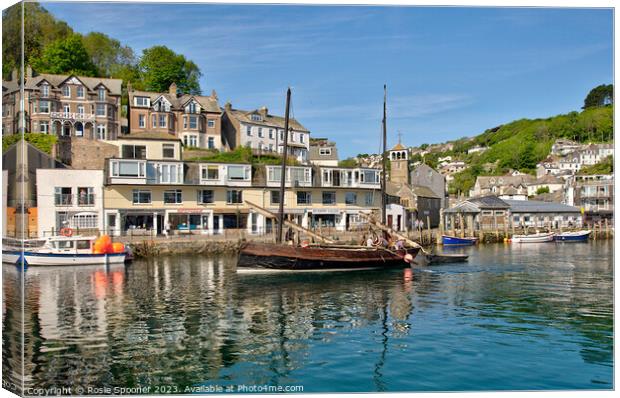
[[136, 46, 202, 94]]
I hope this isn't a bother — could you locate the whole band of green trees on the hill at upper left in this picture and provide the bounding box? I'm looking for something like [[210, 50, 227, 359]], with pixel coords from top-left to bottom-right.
[[2, 2, 202, 94]]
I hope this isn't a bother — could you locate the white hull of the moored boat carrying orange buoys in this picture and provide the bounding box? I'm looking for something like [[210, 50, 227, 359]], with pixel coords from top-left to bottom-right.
[[2, 250, 125, 266]]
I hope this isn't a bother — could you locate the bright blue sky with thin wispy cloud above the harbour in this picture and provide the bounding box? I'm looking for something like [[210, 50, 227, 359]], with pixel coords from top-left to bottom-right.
[[44, 3, 613, 157]]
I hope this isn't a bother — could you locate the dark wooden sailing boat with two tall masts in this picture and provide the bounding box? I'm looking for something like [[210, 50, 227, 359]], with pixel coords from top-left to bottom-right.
[[237, 86, 420, 271]]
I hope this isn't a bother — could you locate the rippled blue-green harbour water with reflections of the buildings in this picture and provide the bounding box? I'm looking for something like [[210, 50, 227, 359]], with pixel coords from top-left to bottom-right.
[[3, 241, 613, 393]]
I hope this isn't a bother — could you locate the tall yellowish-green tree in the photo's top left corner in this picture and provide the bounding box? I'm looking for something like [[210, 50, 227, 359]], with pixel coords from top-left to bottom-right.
[[2, 2, 73, 78]]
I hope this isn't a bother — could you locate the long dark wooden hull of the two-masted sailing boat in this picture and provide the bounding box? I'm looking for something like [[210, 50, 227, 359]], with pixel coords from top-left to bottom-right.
[[237, 243, 418, 270]]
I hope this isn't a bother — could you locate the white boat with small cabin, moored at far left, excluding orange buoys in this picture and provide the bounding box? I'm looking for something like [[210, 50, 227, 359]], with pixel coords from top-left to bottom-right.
[[2, 236, 125, 266]]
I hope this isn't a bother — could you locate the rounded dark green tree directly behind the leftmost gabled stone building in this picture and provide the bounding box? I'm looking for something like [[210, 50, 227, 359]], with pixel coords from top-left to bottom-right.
[[31, 34, 98, 76]]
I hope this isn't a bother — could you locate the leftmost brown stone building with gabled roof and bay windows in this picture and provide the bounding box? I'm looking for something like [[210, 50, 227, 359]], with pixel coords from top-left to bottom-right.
[[2, 66, 122, 140]]
